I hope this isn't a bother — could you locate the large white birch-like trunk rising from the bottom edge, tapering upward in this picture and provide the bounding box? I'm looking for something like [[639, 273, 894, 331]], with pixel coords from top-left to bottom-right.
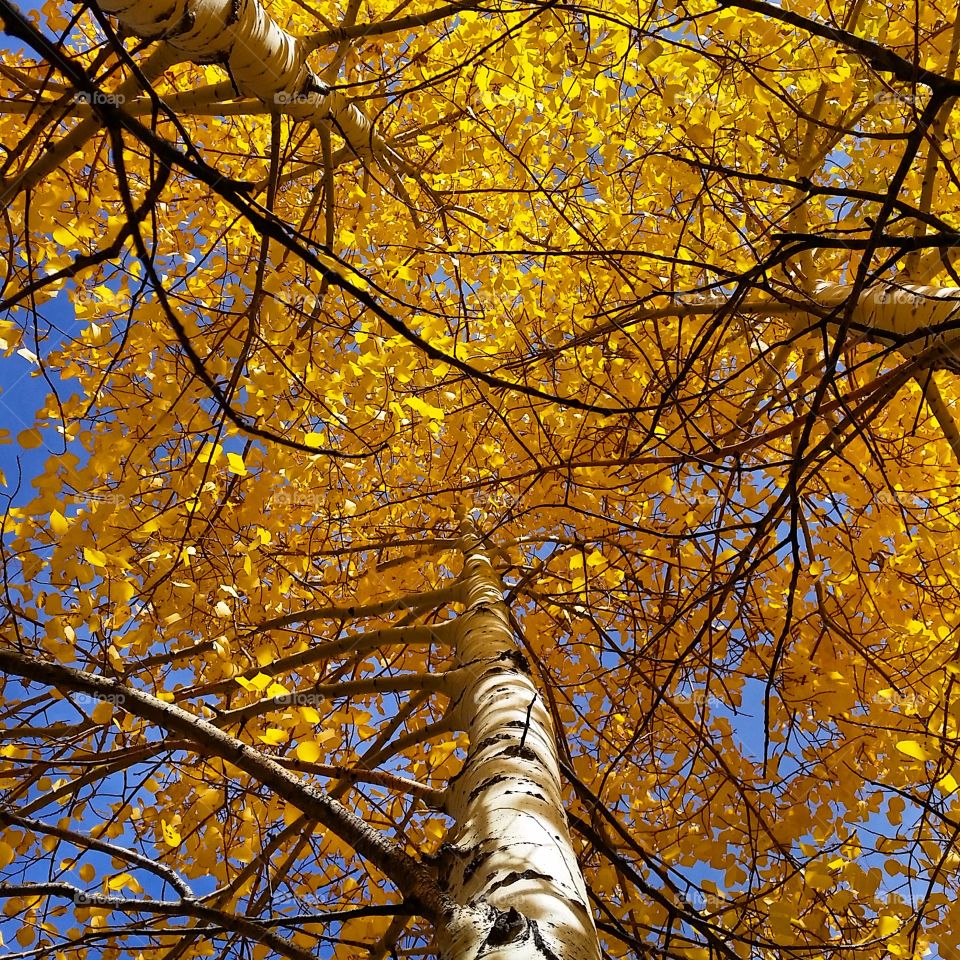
[[437, 523, 600, 960]]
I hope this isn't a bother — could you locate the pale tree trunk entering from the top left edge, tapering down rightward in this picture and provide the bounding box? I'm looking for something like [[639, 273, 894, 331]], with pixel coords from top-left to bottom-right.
[[98, 0, 385, 157]]
